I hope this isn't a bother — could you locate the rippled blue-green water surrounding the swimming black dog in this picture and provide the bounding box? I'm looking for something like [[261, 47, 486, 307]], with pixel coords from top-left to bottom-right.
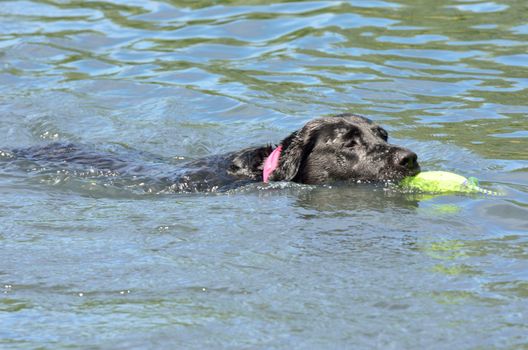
[[0, 0, 528, 349]]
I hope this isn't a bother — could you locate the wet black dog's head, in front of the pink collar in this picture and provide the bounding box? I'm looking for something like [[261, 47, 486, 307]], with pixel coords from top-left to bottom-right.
[[271, 114, 420, 184]]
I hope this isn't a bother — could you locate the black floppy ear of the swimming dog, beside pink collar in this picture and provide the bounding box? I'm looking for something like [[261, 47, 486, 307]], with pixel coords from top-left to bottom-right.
[[271, 122, 317, 182]]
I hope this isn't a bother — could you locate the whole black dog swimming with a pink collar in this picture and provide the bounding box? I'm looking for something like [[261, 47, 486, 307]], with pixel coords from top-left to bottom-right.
[[4, 114, 420, 192]]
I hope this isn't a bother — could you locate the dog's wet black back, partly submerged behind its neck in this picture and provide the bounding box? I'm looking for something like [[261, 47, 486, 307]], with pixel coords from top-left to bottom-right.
[[0, 142, 254, 193]]
